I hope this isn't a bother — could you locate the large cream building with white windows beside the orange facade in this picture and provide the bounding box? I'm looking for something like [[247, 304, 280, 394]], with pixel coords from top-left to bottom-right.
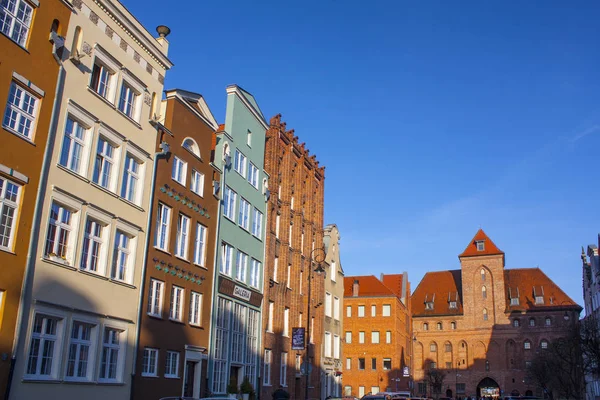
[[10, 0, 172, 400]]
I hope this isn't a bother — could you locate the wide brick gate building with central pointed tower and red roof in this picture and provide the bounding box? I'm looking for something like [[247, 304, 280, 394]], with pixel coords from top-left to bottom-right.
[[412, 229, 581, 397]]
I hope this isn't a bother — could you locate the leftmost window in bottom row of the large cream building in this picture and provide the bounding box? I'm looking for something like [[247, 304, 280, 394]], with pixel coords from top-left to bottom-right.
[[26, 314, 60, 378]]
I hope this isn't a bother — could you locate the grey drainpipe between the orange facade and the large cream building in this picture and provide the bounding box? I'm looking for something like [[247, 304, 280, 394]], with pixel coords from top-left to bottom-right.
[[4, 61, 66, 400]]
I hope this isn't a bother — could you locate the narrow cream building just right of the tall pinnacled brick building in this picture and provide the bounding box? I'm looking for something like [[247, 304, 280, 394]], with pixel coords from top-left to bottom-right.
[[321, 224, 344, 399]]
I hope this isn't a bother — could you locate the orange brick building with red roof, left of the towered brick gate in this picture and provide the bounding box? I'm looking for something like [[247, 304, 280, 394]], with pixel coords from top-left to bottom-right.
[[343, 273, 412, 398]]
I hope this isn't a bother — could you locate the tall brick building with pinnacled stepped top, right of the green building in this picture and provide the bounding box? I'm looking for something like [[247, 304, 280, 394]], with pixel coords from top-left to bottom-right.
[[261, 115, 325, 399]]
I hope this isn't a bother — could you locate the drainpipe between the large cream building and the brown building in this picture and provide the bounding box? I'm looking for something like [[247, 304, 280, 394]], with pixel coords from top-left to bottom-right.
[[129, 138, 170, 400]]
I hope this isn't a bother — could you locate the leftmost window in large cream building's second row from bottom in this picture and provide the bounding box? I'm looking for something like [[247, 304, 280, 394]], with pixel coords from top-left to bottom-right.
[[44, 203, 74, 263]]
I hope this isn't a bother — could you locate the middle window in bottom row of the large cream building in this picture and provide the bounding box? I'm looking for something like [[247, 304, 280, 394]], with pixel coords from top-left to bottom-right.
[[65, 321, 94, 379]]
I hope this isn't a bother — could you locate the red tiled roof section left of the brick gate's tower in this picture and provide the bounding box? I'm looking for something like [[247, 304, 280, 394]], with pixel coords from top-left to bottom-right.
[[411, 269, 463, 317]]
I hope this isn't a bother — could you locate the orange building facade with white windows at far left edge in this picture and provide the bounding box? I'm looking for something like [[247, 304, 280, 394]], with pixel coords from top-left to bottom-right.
[[0, 0, 71, 397]]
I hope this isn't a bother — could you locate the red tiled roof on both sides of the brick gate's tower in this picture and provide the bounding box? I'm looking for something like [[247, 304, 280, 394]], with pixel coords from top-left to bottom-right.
[[411, 268, 581, 317]]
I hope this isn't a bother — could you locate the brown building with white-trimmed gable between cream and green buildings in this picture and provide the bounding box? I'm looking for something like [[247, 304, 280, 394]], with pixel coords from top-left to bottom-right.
[[134, 89, 220, 399]]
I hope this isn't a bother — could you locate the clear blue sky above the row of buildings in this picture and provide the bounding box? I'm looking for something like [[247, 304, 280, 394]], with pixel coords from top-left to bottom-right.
[[123, 0, 600, 310]]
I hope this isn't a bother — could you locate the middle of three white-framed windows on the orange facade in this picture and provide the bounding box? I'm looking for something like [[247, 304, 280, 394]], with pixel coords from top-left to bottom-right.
[[0, 80, 39, 140]]
